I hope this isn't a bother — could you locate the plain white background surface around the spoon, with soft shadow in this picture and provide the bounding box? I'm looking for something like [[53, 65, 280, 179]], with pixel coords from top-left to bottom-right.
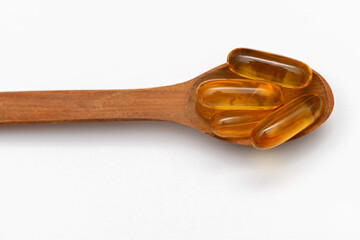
[[0, 0, 360, 240]]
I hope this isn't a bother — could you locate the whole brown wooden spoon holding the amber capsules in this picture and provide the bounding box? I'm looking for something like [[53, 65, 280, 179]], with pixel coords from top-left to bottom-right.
[[0, 64, 334, 145]]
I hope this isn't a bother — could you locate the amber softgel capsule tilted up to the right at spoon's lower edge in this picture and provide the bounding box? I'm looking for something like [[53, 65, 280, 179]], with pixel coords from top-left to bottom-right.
[[251, 94, 323, 149]]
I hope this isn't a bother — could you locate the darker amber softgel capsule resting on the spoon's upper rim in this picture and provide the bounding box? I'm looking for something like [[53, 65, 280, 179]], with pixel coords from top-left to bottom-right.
[[227, 48, 312, 88]]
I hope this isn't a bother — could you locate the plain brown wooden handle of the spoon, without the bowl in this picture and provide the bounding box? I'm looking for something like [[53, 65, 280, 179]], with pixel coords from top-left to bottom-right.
[[0, 83, 187, 125]]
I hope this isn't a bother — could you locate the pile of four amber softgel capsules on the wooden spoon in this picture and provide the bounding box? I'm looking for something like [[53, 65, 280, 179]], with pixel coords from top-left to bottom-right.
[[196, 48, 323, 149]]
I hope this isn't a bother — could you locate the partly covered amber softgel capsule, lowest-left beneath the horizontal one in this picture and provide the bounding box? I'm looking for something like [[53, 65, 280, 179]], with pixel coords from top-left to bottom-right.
[[210, 111, 270, 139]]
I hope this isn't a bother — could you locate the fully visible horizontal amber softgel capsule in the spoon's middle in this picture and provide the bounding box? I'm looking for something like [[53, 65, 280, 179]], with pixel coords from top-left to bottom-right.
[[196, 79, 283, 110]]
